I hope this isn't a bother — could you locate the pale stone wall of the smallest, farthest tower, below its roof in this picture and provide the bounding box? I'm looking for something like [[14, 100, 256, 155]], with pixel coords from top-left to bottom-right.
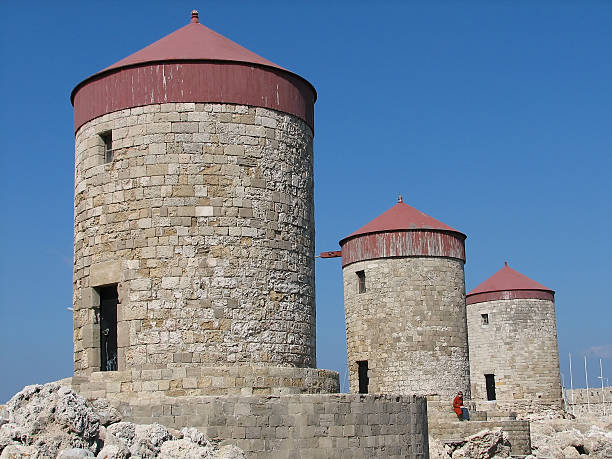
[[467, 299, 562, 413]]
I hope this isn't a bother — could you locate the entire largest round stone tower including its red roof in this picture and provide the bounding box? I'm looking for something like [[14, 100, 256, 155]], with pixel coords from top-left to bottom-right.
[[72, 11, 340, 396]]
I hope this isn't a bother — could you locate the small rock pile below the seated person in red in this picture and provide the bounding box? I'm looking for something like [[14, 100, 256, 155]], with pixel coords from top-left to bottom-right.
[[429, 429, 511, 459]]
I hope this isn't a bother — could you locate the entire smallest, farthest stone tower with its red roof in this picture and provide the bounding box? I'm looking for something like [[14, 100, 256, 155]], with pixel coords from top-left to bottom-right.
[[466, 263, 562, 413]]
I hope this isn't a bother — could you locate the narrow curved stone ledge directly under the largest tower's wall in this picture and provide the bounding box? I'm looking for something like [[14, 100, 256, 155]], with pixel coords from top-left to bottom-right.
[[72, 366, 340, 401]]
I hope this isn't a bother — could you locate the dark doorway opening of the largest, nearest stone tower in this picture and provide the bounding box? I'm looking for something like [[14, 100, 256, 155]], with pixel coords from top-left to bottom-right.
[[98, 284, 119, 371]]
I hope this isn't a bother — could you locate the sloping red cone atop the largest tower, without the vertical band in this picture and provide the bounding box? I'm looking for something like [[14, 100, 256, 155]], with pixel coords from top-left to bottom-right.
[[102, 11, 285, 72]]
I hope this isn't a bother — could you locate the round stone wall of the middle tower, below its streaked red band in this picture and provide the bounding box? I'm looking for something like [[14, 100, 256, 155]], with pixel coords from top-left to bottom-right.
[[343, 257, 470, 397]]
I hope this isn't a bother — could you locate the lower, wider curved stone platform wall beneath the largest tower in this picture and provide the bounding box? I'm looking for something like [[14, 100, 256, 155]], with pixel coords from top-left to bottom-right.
[[93, 394, 429, 459]]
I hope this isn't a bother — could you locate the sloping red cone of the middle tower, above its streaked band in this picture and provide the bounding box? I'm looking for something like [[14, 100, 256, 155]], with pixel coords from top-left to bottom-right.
[[341, 196, 466, 243]]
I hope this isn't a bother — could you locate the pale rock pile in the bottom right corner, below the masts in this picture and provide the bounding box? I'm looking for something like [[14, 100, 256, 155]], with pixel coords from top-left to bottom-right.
[[530, 416, 612, 459]]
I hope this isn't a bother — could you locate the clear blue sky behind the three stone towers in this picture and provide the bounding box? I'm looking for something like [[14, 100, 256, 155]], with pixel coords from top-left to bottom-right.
[[0, 0, 612, 401]]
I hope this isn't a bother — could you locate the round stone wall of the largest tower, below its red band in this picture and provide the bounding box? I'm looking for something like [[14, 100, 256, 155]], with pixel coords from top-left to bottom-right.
[[74, 103, 316, 375]]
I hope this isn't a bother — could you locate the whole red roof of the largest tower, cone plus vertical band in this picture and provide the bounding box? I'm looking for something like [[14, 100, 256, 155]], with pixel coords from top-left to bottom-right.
[[70, 10, 317, 133]]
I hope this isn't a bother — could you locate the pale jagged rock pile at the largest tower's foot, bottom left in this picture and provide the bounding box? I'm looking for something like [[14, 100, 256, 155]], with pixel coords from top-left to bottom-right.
[[0, 383, 245, 459]]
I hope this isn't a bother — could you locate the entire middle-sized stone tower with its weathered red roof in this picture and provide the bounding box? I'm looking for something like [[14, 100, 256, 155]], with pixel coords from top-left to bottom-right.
[[340, 198, 470, 398]]
